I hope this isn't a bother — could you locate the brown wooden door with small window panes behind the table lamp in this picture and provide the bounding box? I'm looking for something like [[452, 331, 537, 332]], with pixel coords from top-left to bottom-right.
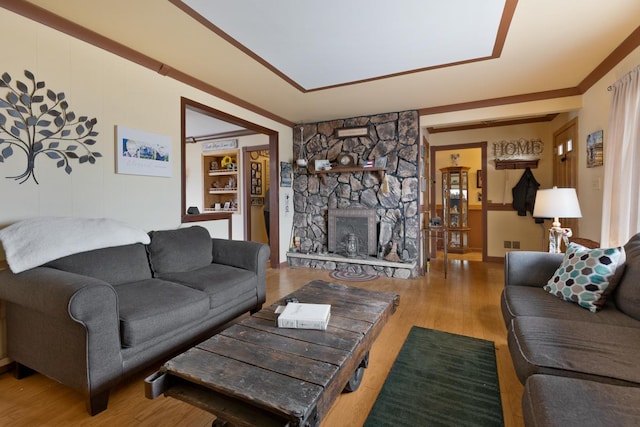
[[553, 118, 579, 236]]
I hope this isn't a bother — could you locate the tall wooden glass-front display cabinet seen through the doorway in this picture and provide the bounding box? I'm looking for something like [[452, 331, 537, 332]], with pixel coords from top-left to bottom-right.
[[440, 166, 470, 253]]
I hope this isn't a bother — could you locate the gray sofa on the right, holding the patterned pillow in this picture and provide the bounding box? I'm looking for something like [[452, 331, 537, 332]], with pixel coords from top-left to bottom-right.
[[501, 234, 640, 426]]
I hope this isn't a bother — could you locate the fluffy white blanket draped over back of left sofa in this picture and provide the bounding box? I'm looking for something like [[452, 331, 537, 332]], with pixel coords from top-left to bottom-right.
[[0, 217, 150, 273]]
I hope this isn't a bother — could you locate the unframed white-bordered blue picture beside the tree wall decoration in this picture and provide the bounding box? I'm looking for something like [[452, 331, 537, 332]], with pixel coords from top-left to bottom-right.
[[115, 126, 172, 177]]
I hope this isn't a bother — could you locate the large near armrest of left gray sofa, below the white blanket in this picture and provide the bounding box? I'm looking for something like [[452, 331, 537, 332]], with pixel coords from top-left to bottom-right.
[[0, 267, 123, 391]]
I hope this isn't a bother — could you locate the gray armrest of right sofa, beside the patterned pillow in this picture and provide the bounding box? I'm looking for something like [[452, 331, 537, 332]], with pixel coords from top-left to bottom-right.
[[504, 251, 564, 287]]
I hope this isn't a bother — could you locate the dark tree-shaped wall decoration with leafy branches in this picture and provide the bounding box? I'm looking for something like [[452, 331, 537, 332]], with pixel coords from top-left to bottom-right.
[[0, 70, 102, 184]]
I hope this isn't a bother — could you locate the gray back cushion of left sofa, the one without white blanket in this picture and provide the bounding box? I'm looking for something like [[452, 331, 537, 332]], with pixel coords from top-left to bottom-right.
[[147, 226, 213, 276]]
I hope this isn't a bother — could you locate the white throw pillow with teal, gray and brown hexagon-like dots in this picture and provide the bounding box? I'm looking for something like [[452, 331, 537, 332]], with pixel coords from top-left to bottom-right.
[[544, 243, 625, 313]]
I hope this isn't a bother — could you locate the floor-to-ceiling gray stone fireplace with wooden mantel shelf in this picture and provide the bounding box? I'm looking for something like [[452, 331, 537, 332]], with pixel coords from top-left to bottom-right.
[[287, 111, 420, 278]]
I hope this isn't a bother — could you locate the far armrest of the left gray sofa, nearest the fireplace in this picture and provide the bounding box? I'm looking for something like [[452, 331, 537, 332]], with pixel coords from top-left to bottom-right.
[[211, 238, 271, 304]]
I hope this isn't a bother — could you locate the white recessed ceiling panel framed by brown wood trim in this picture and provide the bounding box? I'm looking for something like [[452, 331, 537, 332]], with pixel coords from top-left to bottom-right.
[[180, 0, 511, 91]]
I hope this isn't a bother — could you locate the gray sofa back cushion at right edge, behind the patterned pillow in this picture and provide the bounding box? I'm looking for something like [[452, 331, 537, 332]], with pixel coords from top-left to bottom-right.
[[614, 233, 640, 320]]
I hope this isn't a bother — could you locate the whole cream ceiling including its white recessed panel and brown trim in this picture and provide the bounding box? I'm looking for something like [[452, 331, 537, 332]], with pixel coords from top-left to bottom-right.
[[15, 0, 640, 127]]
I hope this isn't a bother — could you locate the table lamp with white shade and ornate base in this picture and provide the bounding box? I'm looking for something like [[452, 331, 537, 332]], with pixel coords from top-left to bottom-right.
[[533, 187, 582, 253]]
